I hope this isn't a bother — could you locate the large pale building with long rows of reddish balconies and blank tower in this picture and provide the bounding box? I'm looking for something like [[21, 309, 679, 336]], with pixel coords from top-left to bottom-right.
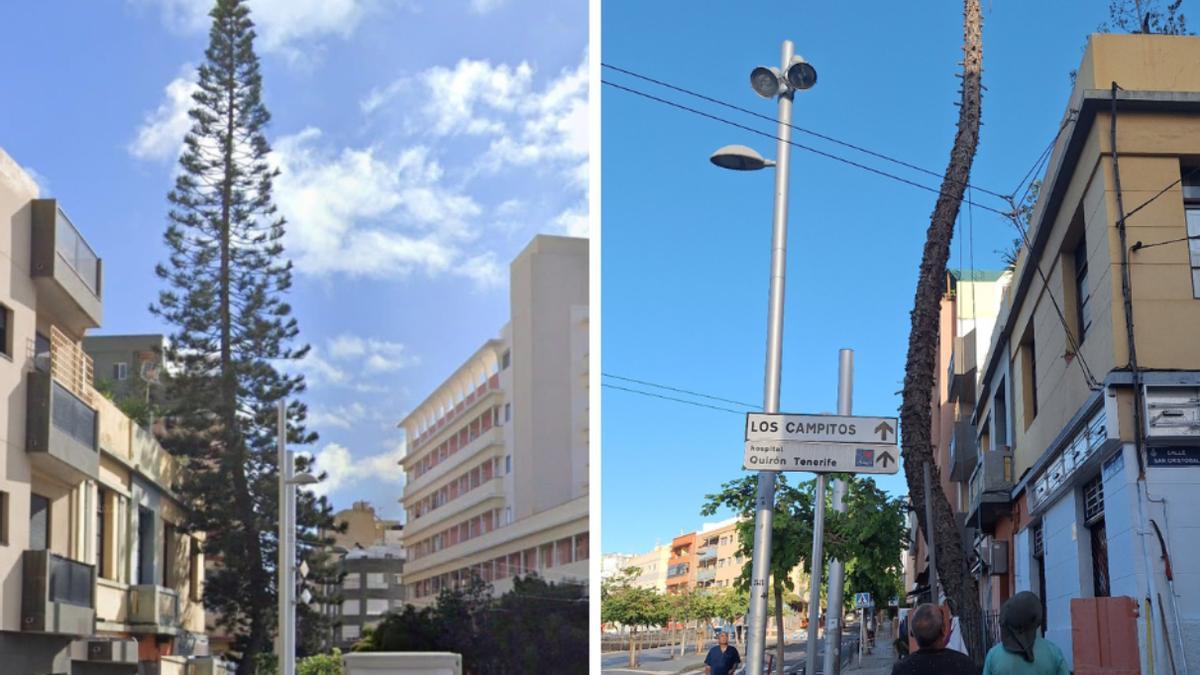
[[401, 235, 588, 605]]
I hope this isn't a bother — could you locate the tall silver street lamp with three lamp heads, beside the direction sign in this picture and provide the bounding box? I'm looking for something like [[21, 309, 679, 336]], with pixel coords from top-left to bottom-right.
[[709, 40, 824, 674]]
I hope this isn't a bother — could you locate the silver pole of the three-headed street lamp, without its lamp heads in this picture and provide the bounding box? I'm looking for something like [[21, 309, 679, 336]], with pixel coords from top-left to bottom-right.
[[746, 40, 794, 675]]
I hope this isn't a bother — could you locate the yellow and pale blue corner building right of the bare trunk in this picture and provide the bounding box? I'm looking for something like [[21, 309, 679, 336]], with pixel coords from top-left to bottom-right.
[[966, 35, 1200, 673]]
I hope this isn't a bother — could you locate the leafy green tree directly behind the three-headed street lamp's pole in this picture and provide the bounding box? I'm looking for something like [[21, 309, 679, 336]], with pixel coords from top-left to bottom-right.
[[700, 474, 816, 675]]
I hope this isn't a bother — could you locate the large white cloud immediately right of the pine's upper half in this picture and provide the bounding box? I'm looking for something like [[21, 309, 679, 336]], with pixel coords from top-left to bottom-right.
[[272, 127, 504, 286]]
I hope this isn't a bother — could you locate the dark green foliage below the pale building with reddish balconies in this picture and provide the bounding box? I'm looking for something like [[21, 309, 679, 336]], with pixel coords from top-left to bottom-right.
[[354, 577, 588, 675]]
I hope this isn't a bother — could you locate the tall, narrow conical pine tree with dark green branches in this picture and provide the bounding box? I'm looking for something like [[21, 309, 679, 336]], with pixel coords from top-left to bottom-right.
[[151, 0, 332, 674]]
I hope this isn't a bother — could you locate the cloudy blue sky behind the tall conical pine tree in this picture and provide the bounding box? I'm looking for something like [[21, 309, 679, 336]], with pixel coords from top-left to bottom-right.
[[0, 0, 588, 516]]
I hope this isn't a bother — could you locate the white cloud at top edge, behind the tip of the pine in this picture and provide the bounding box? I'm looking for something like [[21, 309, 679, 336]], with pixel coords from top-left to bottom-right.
[[142, 0, 398, 59]]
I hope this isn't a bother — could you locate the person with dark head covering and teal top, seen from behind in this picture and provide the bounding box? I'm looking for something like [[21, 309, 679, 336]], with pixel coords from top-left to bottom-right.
[[983, 591, 1070, 675]]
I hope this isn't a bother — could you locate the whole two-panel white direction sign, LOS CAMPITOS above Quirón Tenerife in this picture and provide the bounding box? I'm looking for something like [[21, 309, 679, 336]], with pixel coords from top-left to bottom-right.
[[742, 412, 900, 473]]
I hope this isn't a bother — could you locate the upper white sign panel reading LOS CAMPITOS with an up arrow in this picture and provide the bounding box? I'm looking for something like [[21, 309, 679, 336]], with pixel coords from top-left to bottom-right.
[[746, 412, 899, 446]]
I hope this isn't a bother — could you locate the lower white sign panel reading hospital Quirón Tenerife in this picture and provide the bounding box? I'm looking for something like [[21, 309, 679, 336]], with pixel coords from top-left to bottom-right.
[[742, 441, 900, 473]]
